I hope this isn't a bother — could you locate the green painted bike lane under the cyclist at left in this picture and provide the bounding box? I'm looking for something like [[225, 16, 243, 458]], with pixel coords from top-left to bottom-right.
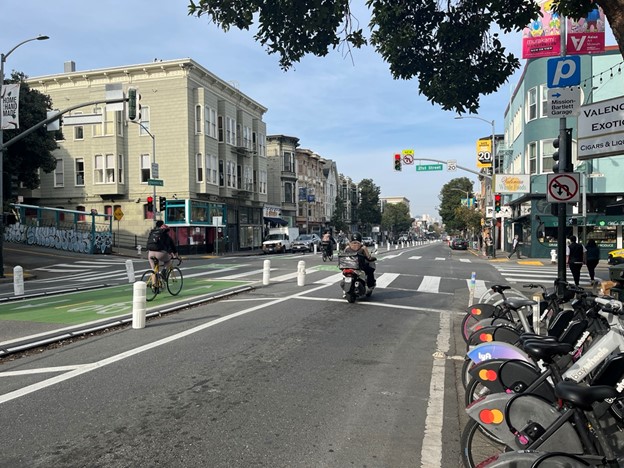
[[0, 277, 250, 325]]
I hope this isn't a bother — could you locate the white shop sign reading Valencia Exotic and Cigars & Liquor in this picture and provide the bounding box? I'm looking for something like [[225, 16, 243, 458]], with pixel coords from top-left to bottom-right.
[[577, 96, 624, 160]]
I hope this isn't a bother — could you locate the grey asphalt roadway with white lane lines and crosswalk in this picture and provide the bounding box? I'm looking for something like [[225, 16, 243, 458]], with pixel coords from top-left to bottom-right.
[[0, 243, 478, 466]]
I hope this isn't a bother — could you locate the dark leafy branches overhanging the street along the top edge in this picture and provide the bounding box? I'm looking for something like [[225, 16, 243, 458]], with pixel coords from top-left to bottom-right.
[[189, 0, 624, 113]]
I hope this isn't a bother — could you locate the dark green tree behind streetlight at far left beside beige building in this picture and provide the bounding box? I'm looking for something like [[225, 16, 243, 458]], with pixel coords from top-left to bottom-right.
[[2, 72, 62, 204]]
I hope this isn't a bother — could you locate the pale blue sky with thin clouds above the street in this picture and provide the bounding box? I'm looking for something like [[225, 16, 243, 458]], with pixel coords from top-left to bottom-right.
[[0, 0, 614, 217]]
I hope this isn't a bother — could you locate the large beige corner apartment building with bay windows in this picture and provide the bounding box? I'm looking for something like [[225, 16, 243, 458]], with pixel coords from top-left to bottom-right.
[[25, 59, 268, 253]]
